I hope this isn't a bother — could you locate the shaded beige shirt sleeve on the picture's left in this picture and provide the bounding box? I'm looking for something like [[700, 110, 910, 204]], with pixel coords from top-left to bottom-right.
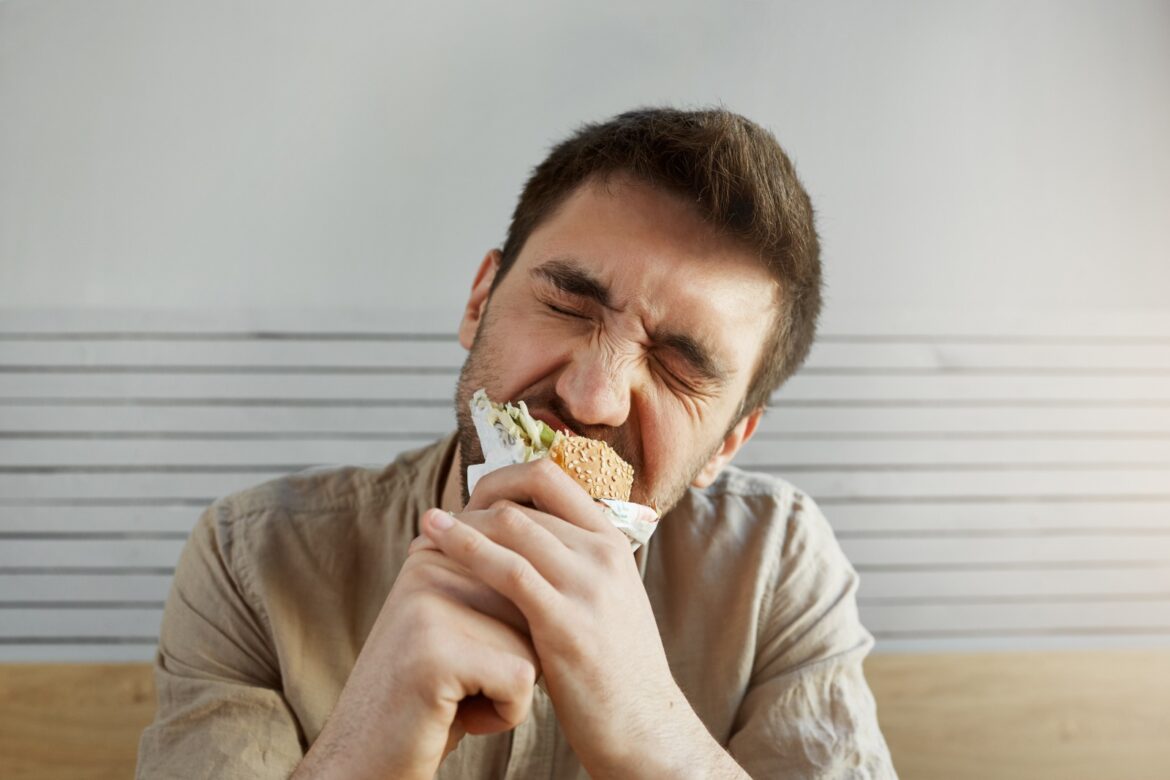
[[137, 502, 304, 779]]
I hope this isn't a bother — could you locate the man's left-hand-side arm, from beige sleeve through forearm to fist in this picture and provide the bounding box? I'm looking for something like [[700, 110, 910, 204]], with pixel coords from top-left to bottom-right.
[[138, 503, 538, 780]]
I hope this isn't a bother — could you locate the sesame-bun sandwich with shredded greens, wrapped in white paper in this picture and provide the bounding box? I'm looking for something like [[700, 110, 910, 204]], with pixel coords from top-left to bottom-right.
[[467, 388, 658, 550]]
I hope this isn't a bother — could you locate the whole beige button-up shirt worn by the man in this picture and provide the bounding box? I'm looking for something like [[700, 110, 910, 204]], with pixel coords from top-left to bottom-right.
[[138, 437, 894, 779]]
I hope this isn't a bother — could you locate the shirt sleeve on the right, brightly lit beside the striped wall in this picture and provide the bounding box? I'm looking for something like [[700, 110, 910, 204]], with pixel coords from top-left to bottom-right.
[[728, 493, 896, 780]]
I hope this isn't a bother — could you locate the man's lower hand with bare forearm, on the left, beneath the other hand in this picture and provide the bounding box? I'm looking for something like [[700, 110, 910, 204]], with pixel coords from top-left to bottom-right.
[[294, 550, 539, 780]]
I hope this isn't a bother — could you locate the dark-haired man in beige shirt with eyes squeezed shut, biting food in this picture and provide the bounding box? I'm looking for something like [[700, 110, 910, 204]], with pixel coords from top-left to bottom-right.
[[139, 110, 893, 779]]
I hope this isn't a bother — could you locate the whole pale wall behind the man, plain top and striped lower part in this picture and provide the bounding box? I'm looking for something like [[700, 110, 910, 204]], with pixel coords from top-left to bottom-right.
[[0, 0, 1170, 662]]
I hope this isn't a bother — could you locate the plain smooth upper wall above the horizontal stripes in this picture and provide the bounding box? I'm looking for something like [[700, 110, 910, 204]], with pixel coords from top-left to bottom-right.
[[0, 0, 1170, 318]]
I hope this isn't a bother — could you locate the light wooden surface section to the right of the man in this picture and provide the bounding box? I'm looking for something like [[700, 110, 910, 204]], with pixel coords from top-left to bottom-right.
[[866, 650, 1170, 780]]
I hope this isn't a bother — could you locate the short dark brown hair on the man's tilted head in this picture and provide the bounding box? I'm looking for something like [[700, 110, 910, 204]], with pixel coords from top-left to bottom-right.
[[494, 108, 821, 422]]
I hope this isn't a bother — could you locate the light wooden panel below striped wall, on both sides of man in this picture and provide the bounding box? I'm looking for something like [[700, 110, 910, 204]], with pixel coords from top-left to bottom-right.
[[0, 651, 1170, 780]]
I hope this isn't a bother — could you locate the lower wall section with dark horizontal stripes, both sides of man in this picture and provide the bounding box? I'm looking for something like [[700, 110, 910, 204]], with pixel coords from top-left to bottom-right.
[[0, 312, 1170, 661]]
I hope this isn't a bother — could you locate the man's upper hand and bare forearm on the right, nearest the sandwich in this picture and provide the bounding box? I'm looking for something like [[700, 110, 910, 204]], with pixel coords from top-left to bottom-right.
[[422, 460, 743, 776]]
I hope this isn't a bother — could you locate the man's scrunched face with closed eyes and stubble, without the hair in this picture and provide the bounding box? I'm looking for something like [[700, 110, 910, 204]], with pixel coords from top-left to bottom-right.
[[456, 178, 779, 512]]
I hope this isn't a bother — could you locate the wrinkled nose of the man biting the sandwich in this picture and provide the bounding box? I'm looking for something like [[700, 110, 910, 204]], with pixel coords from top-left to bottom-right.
[[557, 347, 632, 428]]
